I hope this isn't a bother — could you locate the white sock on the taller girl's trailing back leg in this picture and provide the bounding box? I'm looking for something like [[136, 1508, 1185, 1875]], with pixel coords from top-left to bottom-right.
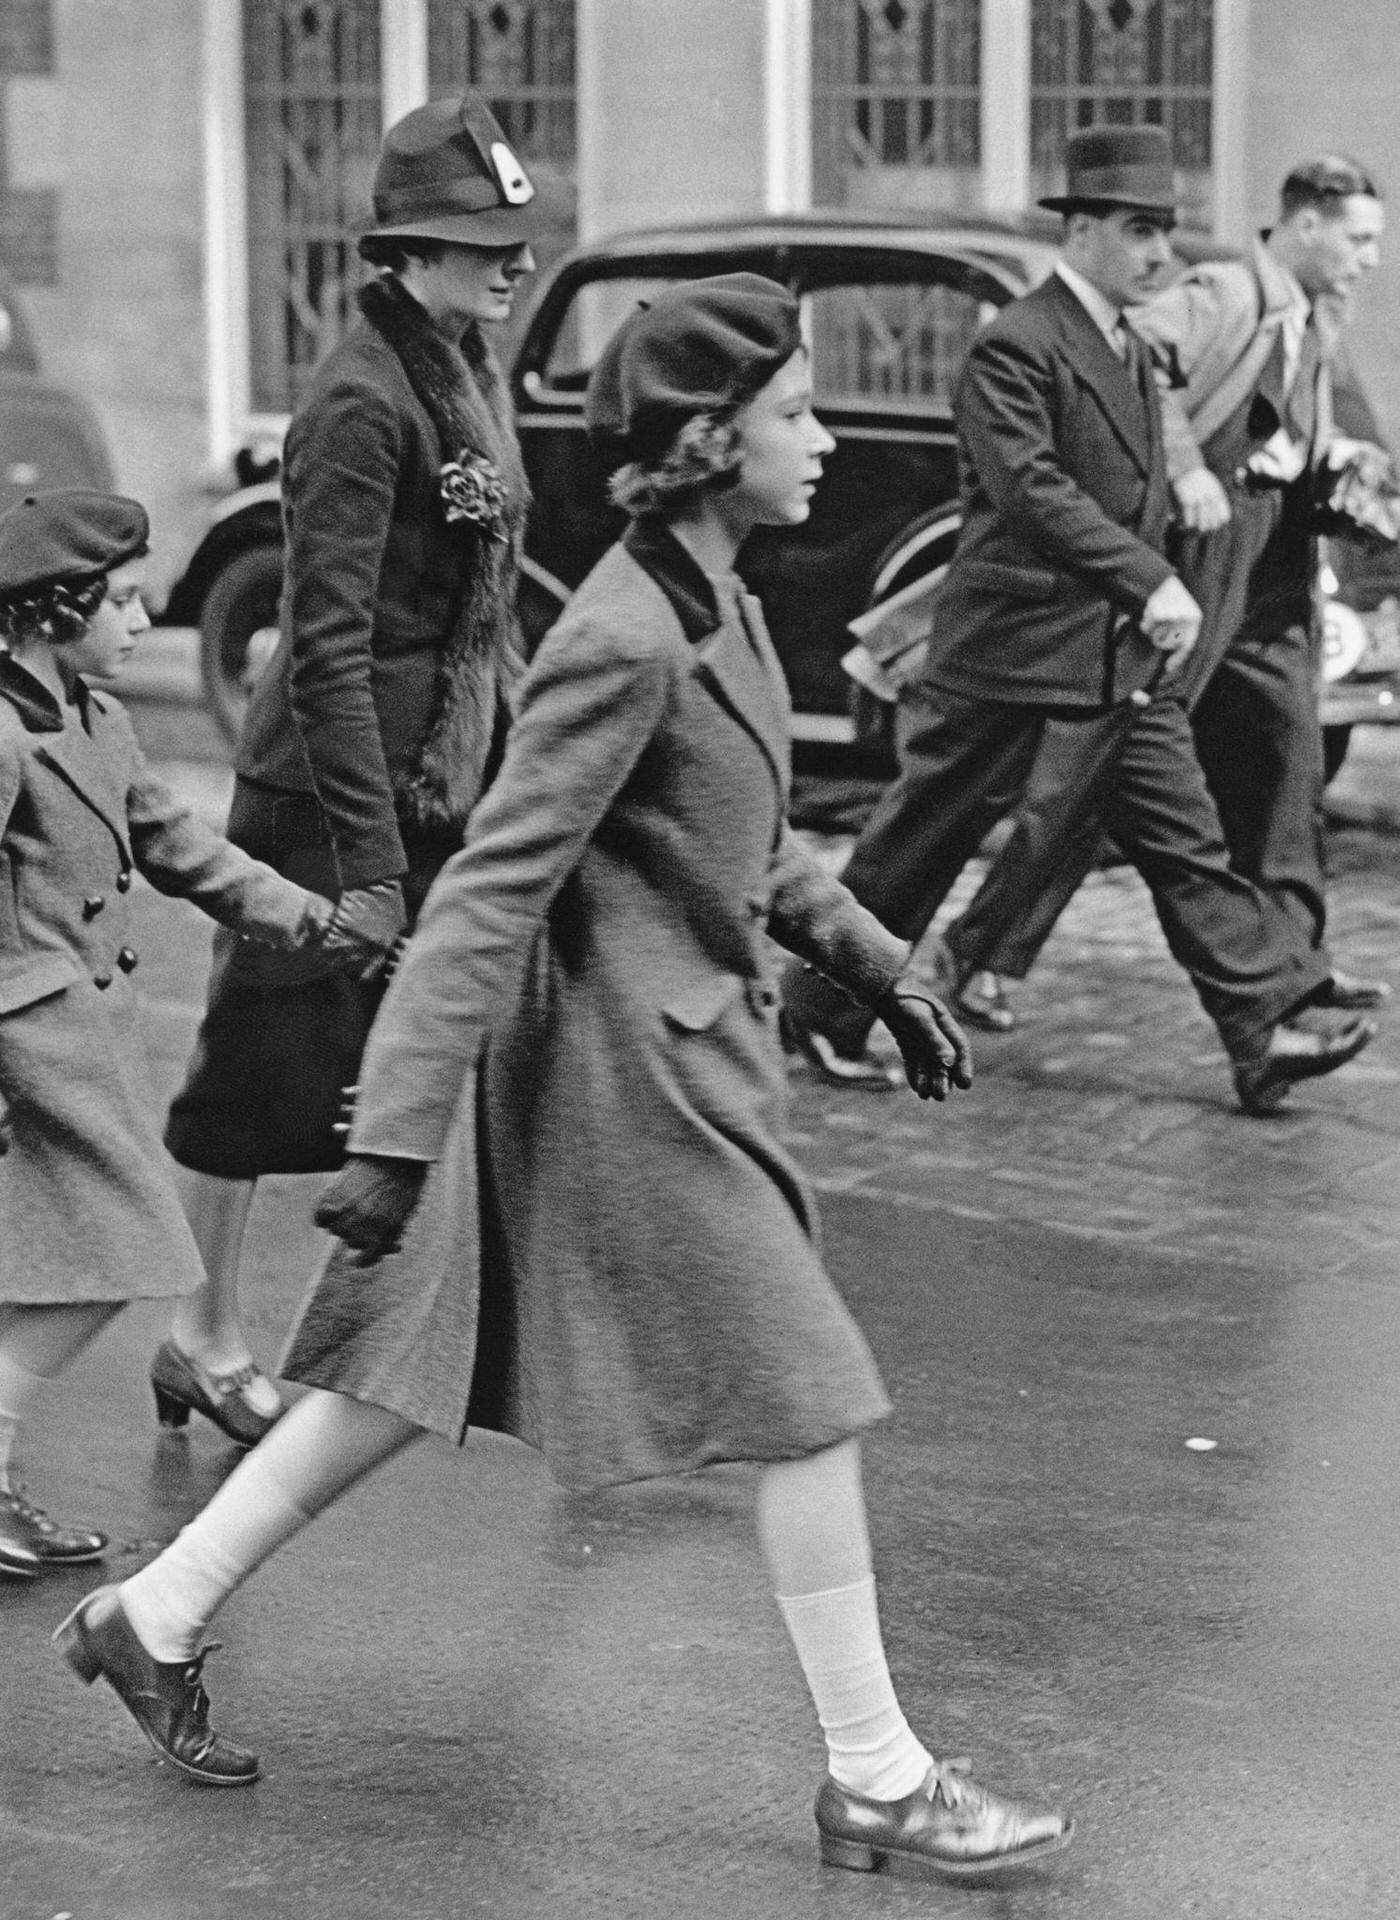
[[121, 1452, 311, 1661]]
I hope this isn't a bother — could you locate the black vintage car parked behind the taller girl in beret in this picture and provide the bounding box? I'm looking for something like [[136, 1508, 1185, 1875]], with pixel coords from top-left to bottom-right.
[[165, 209, 1400, 778]]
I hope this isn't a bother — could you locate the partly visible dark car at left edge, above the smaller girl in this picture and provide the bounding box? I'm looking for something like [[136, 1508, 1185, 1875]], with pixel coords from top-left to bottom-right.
[[0, 275, 113, 513]]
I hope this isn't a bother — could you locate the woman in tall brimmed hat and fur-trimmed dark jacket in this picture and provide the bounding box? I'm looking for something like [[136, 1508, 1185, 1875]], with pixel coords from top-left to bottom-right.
[[152, 94, 536, 1446]]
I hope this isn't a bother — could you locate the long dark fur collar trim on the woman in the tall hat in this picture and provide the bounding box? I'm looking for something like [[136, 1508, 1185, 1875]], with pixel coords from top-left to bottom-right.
[[359, 275, 530, 829]]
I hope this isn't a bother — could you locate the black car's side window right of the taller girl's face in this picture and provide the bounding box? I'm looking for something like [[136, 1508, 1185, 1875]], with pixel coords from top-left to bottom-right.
[[803, 280, 997, 405]]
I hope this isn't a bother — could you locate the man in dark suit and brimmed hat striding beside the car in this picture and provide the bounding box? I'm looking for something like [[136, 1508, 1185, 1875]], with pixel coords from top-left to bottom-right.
[[784, 127, 1373, 1112]]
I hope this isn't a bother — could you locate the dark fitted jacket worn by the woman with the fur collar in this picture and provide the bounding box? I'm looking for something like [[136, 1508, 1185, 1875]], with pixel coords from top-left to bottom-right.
[[236, 319, 476, 887]]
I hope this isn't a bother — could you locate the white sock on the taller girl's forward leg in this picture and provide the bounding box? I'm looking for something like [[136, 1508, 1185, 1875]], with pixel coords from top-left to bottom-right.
[[778, 1574, 933, 1799]]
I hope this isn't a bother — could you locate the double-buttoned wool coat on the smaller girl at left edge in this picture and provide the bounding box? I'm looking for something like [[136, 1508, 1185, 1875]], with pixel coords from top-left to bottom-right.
[[0, 657, 307, 1304]]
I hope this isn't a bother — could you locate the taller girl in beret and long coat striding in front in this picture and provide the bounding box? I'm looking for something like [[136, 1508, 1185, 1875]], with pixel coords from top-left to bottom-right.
[[60, 275, 1068, 1876]]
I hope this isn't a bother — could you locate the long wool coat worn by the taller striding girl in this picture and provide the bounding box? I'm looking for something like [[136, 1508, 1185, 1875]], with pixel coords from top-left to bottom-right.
[[284, 526, 906, 1486]]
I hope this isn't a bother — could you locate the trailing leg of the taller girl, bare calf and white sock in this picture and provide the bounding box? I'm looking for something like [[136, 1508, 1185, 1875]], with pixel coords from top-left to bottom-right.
[[121, 1392, 422, 1661]]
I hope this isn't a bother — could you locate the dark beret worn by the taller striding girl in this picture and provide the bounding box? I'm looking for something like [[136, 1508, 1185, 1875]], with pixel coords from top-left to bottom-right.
[[584, 273, 803, 459]]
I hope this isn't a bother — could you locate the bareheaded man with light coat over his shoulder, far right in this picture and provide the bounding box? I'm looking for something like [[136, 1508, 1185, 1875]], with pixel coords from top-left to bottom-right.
[[947, 154, 1390, 1029]]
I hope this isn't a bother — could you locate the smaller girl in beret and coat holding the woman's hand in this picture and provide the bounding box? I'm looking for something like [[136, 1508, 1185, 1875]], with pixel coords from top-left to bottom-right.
[[0, 490, 338, 1578]]
